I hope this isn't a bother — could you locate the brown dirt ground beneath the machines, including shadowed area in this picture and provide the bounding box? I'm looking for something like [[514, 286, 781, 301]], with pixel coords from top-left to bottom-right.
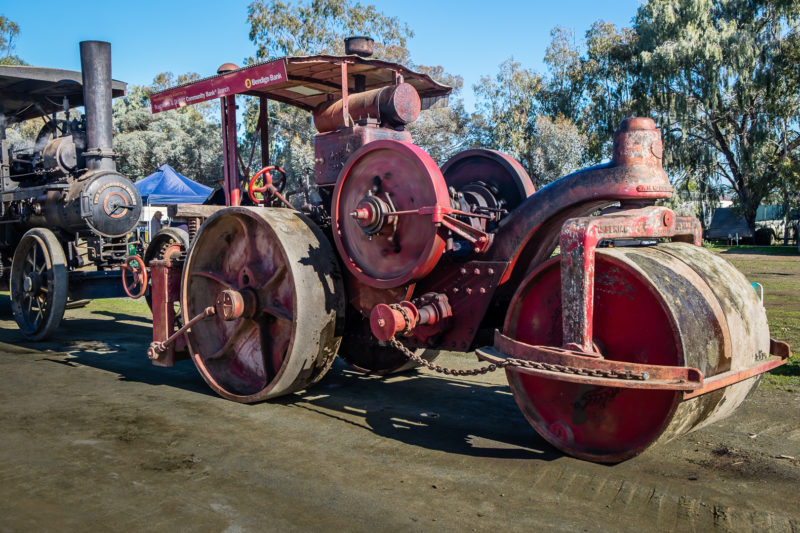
[[0, 251, 800, 532]]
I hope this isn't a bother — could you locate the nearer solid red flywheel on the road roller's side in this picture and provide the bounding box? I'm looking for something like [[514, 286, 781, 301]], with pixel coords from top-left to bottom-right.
[[331, 140, 450, 288]]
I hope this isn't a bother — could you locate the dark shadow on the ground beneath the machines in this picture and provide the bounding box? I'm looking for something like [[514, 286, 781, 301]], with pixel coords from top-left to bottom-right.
[[0, 298, 562, 461]]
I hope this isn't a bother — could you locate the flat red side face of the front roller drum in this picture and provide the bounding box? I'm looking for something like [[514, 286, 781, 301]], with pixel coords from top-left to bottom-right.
[[504, 254, 683, 462]]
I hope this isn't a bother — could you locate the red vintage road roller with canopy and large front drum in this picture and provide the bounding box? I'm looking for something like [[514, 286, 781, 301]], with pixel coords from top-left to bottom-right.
[[128, 39, 790, 462]]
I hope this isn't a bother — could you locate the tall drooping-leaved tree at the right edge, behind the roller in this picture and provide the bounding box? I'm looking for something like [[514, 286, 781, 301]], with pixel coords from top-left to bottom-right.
[[633, 0, 800, 228]]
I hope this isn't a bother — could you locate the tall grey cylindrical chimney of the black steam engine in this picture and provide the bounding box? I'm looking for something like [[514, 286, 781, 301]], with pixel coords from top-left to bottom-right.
[[81, 41, 117, 171]]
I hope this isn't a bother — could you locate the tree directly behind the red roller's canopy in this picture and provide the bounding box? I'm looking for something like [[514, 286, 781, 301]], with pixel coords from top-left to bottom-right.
[[242, 0, 466, 188]]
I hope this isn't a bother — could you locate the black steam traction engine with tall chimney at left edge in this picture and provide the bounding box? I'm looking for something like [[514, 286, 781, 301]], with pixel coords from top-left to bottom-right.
[[0, 41, 142, 340]]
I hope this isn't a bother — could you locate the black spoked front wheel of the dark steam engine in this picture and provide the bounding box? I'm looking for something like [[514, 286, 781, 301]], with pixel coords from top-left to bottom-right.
[[10, 228, 68, 341]]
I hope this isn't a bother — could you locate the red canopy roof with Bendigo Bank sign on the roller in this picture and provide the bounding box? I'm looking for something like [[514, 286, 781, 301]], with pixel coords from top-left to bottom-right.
[[150, 55, 453, 113]]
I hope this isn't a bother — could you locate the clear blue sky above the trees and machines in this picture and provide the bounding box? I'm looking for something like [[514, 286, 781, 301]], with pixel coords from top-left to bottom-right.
[[0, 0, 641, 109]]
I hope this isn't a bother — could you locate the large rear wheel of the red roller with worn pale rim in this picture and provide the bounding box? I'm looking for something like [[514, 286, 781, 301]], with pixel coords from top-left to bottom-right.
[[181, 207, 344, 403]]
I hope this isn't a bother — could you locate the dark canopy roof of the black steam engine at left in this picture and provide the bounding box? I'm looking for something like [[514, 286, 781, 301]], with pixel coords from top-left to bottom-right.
[[0, 65, 125, 124]]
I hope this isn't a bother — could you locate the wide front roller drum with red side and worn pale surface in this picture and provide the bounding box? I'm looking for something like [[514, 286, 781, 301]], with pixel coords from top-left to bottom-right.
[[504, 243, 770, 462]]
